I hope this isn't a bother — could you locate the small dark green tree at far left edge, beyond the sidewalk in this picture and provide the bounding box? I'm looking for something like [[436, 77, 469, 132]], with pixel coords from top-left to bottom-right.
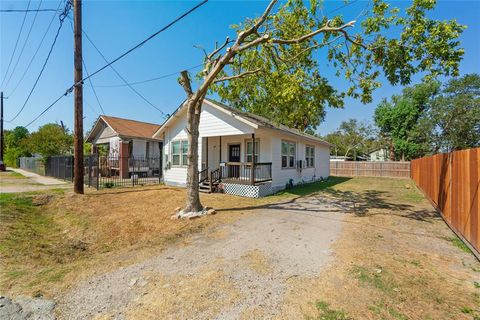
[[4, 127, 31, 167]]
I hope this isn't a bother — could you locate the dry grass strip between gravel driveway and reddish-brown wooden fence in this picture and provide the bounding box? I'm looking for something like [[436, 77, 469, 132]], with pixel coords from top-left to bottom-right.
[[279, 178, 480, 319]]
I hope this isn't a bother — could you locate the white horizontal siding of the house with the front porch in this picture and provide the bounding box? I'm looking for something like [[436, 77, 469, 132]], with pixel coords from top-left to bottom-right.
[[163, 104, 330, 191]]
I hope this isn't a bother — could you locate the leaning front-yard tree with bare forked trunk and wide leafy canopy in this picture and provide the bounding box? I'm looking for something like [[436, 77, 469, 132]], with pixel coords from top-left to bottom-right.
[[180, 0, 464, 212]]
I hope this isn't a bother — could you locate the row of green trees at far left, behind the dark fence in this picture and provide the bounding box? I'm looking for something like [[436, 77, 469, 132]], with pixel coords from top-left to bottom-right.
[[4, 123, 73, 167]]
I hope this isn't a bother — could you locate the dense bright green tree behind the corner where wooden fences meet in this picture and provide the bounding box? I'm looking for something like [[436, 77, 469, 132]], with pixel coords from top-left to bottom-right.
[[374, 82, 440, 160]]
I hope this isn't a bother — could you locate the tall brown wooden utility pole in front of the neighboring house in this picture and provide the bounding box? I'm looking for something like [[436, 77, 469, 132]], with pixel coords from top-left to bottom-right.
[[73, 0, 84, 194]]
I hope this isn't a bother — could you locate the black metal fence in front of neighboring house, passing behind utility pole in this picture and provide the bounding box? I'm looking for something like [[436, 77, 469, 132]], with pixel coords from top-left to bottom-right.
[[20, 154, 162, 189]]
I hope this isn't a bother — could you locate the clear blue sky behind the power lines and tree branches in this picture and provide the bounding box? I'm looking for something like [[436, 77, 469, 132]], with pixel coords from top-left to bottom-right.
[[0, 0, 480, 134]]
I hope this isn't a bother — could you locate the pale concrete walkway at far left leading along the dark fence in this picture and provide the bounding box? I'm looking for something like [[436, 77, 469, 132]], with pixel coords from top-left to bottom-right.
[[0, 168, 72, 193]]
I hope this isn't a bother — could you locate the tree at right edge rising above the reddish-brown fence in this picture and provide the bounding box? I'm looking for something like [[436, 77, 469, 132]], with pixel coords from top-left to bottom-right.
[[423, 74, 480, 152]]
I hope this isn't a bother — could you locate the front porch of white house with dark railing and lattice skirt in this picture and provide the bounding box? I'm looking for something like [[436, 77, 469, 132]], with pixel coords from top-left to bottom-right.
[[199, 133, 272, 197]]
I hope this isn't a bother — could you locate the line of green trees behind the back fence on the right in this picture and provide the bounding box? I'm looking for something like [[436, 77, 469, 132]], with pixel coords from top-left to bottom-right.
[[324, 74, 480, 160]]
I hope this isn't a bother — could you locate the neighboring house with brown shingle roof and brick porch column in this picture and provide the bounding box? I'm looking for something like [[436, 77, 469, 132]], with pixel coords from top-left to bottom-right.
[[86, 115, 163, 179]]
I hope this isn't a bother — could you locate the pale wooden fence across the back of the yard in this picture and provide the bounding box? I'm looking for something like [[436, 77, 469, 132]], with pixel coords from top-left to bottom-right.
[[330, 161, 410, 178]]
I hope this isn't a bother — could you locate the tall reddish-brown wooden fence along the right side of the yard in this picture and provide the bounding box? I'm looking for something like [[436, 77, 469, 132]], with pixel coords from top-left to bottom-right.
[[411, 148, 480, 257]]
